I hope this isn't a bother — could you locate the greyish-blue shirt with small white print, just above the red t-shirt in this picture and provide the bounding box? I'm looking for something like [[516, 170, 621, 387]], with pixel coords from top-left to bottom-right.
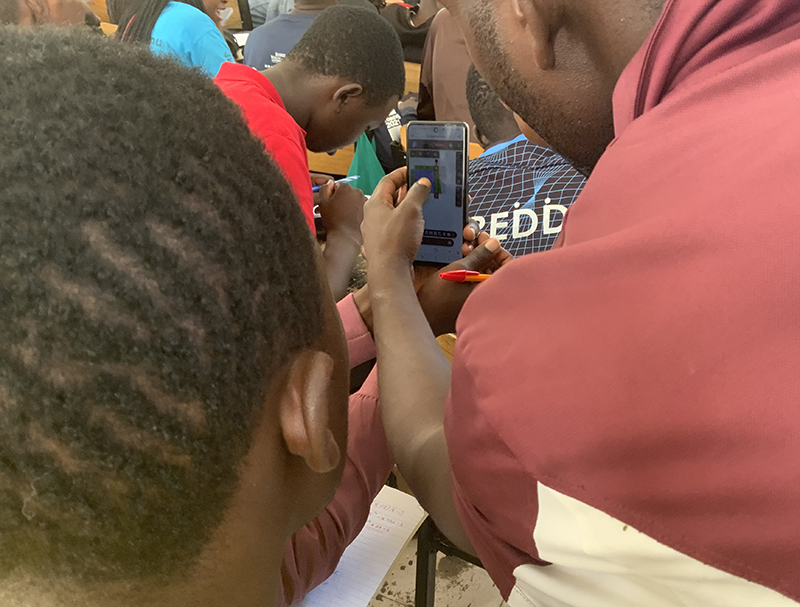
[[244, 13, 319, 71]]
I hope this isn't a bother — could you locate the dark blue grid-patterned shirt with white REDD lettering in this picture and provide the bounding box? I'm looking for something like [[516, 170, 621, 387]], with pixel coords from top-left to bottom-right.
[[469, 135, 586, 257]]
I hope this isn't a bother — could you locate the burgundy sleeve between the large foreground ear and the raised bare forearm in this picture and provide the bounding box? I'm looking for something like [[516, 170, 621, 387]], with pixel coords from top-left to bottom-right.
[[278, 296, 394, 607]]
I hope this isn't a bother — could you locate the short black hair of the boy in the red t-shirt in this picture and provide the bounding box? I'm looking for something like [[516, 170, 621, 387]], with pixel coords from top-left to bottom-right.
[[285, 6, 406, 107]]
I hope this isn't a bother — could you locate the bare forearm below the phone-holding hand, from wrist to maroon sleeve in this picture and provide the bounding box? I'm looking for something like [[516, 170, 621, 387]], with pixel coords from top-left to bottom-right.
[[370, 267, 471, 551]]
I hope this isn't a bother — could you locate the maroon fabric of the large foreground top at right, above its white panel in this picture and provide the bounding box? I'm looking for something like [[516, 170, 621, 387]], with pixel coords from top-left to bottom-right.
[[445, 0, 800, 607]]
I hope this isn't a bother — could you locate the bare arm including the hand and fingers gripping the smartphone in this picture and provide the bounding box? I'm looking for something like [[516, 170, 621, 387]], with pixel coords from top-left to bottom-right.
[[363, 169, 502, 552]]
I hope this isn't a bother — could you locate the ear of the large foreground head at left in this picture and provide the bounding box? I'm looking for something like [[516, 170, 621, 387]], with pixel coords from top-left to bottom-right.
[[280, 350, 342, 474]]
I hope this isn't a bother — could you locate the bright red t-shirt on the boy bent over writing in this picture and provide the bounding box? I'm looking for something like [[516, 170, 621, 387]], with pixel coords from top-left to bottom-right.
[[214, 63, 316, 232]]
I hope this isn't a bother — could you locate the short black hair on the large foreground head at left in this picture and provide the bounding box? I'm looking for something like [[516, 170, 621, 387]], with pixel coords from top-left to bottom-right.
[[0, 27, 324, 583]]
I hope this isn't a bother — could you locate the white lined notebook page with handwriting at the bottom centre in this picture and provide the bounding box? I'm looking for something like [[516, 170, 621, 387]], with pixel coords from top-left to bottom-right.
[[297, 487, 426, 607]]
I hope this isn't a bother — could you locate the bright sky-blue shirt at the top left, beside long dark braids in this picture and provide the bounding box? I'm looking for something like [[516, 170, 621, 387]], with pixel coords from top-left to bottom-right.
[[150, 0, 233, 78]]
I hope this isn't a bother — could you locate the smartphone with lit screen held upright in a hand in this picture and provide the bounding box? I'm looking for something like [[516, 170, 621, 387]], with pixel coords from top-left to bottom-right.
[[406, 121, 469, 265]]
